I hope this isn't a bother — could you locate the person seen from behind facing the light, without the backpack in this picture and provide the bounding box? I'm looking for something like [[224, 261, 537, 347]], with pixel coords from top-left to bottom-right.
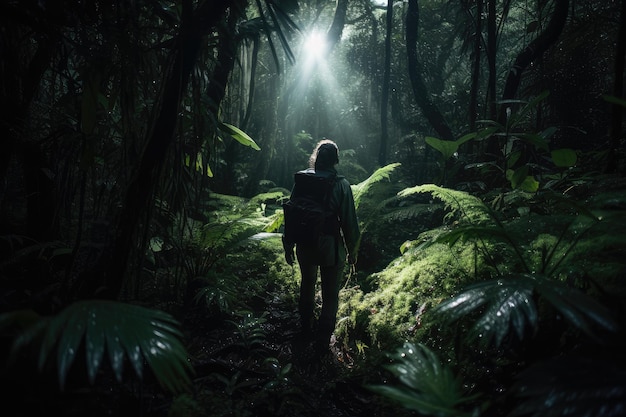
[[283, 139, 360, 356]]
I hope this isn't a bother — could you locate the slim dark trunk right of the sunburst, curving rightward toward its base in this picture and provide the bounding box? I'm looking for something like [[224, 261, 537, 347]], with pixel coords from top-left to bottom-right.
[[406, 0, 454, 140]]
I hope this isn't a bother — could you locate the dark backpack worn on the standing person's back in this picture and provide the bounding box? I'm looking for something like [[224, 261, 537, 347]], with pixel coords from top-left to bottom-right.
[[282, 171, 339, 245]]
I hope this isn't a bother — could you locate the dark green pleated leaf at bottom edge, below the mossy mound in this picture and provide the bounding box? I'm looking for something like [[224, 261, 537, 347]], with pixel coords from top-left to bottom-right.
[[368, 342, 475, 417]]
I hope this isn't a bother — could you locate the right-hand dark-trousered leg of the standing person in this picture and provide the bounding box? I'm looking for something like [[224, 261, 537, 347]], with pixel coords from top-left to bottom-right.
[[316, 265, 343, 351]]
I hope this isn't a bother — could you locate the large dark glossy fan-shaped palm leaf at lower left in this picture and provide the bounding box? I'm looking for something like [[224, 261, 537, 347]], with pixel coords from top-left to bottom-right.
[[0, 300, 192, 392]]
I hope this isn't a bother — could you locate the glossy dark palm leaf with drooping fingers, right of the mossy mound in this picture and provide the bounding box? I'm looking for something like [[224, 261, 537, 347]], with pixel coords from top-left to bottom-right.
[[435, 274, 618, 346]]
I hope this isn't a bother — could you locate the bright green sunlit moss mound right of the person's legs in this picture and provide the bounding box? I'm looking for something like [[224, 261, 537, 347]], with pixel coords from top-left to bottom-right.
[[338, 236, 484, 350]]
